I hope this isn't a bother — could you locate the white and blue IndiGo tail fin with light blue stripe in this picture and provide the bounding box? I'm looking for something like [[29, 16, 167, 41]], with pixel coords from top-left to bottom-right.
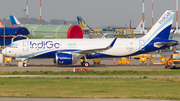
[[142, 10, 175, 42]]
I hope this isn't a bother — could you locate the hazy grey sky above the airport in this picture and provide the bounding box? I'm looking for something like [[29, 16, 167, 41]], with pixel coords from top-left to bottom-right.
[[0, 0, 180, 28]]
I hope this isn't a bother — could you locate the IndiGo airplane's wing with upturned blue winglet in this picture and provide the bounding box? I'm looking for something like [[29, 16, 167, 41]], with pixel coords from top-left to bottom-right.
[[76, 37, 117, 55]]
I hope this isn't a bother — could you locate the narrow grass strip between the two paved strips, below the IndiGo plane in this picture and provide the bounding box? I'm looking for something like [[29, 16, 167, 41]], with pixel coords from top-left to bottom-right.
[[0, 70, 180, 75]]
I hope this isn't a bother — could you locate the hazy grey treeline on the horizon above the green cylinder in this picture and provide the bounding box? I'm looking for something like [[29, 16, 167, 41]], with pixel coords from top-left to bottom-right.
[[0, 18, 77, 27]]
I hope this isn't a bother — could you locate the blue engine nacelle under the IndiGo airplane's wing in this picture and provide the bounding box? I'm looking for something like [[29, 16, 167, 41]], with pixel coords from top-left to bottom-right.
[[55, 53, 73, 65]]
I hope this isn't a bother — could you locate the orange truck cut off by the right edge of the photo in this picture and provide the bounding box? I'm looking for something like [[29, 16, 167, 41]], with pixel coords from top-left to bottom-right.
[[165, 52, 180, 68]]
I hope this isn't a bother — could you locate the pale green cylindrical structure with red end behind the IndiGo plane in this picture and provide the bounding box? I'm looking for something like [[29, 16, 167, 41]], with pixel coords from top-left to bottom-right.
[[20, 25, 83, 39]]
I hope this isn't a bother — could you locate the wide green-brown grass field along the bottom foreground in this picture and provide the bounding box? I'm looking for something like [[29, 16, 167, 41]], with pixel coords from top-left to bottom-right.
[[0, 77, 180, 100]]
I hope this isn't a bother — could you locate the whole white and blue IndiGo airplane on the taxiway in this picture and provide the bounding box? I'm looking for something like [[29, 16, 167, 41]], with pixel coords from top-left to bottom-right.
[[2, 10, 178, 67]]
